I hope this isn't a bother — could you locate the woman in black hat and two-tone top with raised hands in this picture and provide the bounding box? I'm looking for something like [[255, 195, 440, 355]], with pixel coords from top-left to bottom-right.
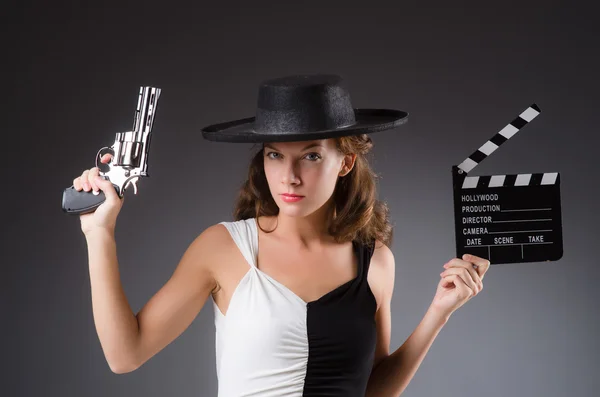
[[73, 75, 489, 397]]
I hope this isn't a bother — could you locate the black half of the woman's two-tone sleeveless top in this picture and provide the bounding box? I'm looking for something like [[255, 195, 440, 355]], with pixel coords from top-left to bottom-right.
[[303, 238, 377, 397]]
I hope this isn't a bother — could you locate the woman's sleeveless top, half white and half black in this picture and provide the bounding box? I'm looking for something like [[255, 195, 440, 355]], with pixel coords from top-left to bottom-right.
[[213, 218, 377, 397]]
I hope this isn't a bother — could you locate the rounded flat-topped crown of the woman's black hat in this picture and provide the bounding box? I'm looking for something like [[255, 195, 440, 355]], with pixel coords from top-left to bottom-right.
[[255, 74, 356, 134]]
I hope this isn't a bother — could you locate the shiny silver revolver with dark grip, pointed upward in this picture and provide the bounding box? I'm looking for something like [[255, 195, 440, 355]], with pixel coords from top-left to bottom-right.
[[62, 87, 160, 214]]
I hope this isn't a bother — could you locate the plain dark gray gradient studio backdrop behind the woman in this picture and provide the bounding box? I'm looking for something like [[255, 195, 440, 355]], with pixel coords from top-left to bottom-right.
[[5, 1, 600, 397]]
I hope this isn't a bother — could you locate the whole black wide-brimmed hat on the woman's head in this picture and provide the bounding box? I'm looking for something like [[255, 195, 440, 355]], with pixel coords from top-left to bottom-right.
[[202, 74, 408, 143]]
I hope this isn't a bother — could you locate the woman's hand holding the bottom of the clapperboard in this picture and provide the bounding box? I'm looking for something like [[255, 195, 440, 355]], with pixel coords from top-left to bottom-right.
[[431, 254, 490, 318]]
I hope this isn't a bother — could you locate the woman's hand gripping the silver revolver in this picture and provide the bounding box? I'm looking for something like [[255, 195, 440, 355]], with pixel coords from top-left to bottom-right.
[[73, 153, 125, 235]]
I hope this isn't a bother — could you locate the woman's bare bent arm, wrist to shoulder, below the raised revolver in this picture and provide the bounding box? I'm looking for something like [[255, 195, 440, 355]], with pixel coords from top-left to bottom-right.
[[86, 226, 225, 373]]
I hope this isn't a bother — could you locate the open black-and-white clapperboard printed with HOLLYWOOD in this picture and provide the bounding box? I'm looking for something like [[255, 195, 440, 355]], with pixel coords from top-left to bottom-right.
[[452, 104, 563, 265]]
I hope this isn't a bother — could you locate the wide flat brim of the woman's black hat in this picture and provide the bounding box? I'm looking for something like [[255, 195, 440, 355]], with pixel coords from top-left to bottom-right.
[[202, 109, 408, 143]]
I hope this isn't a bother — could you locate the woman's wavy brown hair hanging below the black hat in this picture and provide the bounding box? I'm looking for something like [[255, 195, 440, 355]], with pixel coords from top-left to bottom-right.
[[233, 134, 393, 247]]
